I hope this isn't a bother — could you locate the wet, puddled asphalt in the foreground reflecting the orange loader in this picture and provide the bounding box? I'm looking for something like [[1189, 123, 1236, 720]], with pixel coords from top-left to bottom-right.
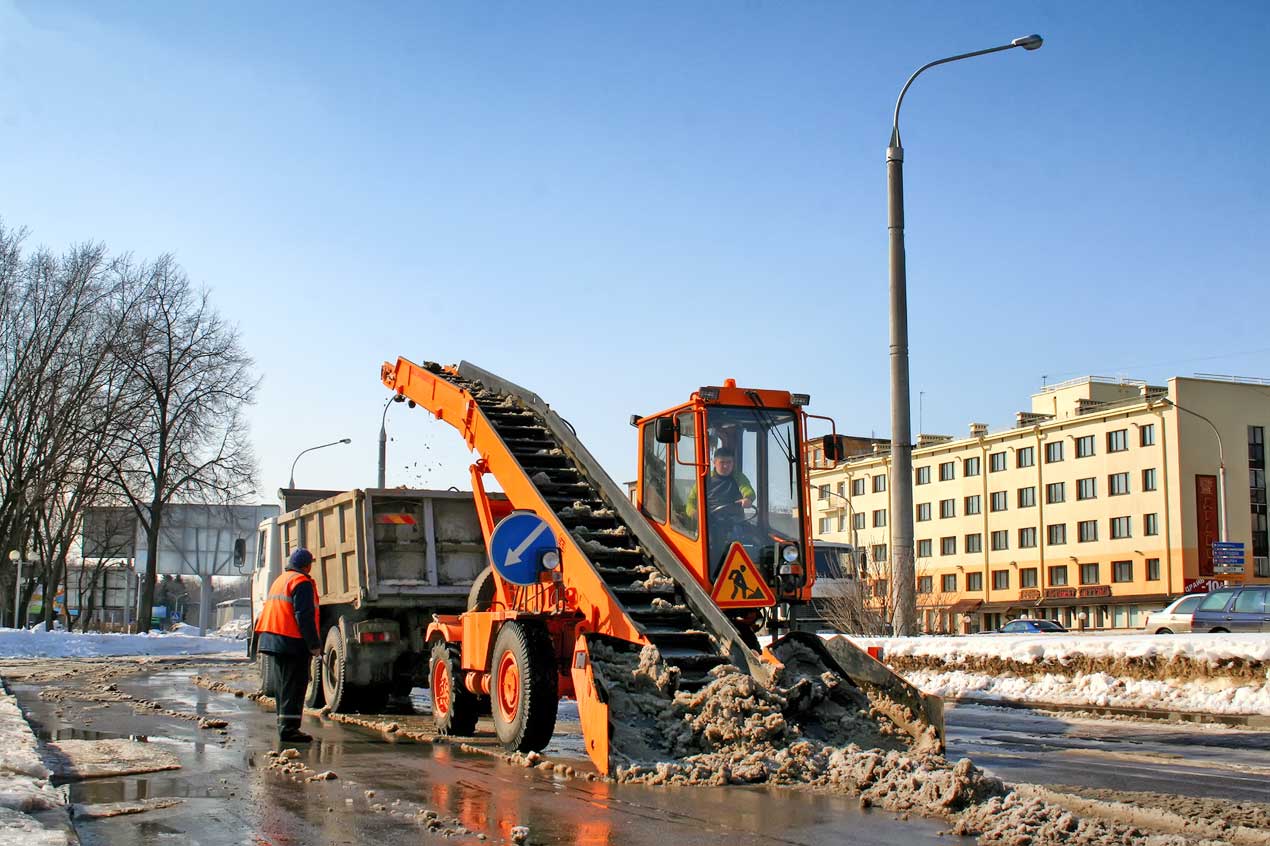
[[13, 671, 969, 846]]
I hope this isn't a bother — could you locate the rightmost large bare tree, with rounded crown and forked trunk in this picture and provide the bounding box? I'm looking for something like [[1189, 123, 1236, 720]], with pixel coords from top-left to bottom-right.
[[106, 255, 259, 628]]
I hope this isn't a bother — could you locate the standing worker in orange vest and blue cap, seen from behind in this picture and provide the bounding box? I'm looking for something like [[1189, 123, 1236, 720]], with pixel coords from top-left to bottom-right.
[[255, 546, 321, 743]]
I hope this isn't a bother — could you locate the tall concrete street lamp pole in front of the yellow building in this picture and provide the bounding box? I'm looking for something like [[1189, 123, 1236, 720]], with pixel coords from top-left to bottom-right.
[[886, 36, 1043, 635]]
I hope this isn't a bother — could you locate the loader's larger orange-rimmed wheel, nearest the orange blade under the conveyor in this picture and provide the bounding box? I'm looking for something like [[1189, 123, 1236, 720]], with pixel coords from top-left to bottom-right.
[[490, 622, 560, 752]]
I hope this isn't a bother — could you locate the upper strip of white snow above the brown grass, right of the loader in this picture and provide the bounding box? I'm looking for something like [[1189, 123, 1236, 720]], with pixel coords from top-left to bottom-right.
[[845, 633, 1270, 667]]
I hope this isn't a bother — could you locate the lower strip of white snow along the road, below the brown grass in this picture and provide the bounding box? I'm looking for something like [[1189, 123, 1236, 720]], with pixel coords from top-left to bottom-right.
[[904, 669, 1270, 714]]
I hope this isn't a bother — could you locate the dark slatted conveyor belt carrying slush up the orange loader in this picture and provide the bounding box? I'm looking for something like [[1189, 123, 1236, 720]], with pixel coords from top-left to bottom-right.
[[424, 362, 771, 690]]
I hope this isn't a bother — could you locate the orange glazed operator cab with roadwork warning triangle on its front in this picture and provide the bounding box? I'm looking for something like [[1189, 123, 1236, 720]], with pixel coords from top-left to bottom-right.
[[631, 380, 841, 628]]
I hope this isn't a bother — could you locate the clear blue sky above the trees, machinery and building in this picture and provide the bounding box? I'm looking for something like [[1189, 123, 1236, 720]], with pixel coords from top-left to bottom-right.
[[0, 0, 1270, 500]]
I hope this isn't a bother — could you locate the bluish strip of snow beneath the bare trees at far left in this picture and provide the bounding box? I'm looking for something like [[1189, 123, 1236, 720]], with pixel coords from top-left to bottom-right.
[[0, 629, 243, 658]]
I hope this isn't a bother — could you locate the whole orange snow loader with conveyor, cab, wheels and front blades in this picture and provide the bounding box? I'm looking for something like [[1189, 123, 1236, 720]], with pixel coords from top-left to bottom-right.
[[381, 358, 944, 774]]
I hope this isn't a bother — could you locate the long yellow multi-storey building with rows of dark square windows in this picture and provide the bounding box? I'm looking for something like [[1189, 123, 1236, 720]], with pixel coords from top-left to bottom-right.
[[810, 376, 1270, 633]]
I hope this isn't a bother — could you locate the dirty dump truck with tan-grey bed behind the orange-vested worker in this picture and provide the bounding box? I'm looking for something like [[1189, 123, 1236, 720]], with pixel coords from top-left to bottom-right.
[[249, 488, 488, 711]]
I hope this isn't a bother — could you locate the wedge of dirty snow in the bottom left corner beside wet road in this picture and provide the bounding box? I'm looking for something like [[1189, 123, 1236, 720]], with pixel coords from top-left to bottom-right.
[[0, 680, 76, 846]]
